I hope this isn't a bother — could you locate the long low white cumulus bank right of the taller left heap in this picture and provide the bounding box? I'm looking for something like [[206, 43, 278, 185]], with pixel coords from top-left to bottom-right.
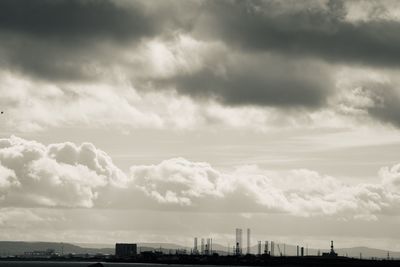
[[131, 158, 400, 219]]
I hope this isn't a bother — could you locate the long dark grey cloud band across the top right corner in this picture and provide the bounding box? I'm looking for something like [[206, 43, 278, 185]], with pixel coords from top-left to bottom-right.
[[196, 1, 400, 66]]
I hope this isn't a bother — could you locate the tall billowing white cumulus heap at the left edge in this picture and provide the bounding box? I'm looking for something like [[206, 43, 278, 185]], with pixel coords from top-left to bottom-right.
[[0, 136, 126, 207]]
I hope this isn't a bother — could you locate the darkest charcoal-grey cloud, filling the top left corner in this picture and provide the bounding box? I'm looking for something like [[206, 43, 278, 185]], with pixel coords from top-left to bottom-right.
[[0, 0, 157, 41]]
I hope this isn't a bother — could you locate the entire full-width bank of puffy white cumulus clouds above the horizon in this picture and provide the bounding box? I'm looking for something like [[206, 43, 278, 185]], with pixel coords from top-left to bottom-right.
[[0, 136, 400, 220]]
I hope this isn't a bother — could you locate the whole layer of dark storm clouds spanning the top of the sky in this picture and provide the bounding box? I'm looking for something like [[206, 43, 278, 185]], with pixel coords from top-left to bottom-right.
[[0, 0, 400, 126]]
